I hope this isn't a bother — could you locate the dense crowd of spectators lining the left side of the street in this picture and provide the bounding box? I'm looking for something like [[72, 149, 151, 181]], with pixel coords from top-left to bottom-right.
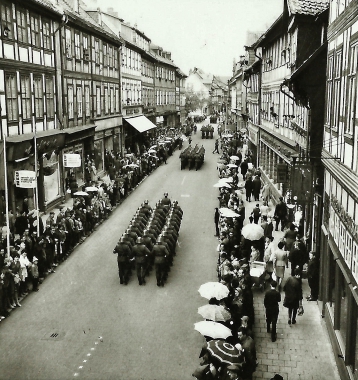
[[0, 133, 181, 321]]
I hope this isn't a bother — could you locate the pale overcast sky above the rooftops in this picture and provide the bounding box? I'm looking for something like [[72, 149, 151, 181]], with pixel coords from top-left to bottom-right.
[[84, 0, 283, 76]]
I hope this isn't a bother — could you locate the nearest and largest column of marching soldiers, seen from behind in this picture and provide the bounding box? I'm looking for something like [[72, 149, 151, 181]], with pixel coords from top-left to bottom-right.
[[113, 193, 183, 286]]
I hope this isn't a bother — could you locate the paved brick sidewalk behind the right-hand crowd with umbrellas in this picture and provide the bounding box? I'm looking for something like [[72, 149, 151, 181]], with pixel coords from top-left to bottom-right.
[[244, 197, 340, 380]]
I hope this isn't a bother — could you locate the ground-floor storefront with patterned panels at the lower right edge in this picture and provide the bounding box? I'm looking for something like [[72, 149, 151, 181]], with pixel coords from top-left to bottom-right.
[[320, 190, 358, 379]]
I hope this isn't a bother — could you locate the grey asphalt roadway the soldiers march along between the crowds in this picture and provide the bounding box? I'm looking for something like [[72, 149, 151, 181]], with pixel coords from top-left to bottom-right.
[[0, 120, 221, 380]]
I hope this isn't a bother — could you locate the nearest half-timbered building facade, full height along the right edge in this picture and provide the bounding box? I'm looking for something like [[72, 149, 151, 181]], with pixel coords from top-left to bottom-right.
[[320, 1, 358, 379]]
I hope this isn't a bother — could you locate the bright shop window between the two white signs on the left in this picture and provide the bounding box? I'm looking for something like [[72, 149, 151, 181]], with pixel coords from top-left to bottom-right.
[[43, 152, 60, 203]]
